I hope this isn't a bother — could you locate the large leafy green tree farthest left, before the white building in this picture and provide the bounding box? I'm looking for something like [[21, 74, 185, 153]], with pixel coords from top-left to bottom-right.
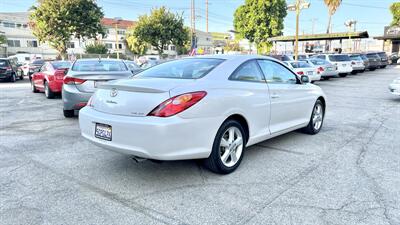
[[30, 0, 105, 58]]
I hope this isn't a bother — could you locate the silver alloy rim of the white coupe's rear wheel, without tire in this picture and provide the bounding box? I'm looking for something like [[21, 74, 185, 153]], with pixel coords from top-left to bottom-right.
[[219, 127, 244, 167]]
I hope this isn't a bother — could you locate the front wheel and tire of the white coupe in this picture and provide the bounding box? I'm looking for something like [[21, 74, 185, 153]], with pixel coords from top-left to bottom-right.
[[302, 99, 325, 135]]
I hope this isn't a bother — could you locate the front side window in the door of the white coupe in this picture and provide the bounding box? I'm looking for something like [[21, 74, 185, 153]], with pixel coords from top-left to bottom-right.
[[257, 59, 297, 84]]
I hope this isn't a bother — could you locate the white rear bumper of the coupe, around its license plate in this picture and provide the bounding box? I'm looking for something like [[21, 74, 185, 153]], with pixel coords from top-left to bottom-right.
[[79, 107, 222, 160]]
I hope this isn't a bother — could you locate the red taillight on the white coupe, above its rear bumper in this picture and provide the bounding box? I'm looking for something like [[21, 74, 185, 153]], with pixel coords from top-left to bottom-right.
[[148, 91, 207, 117]]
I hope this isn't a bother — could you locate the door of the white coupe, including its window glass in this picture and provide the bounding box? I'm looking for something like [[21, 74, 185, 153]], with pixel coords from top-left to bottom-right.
[[258, 59, 314, 134]]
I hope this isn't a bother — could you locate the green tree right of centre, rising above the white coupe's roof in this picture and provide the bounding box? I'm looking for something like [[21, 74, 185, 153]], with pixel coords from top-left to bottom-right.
[[233, 0, 287, 52]]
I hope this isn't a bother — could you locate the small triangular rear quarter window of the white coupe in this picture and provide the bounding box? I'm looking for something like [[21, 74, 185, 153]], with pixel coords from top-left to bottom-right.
[[229, 60, 265, 82]]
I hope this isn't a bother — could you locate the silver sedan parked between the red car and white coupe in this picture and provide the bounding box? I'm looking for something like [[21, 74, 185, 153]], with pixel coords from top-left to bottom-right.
[[62, 59, 132, 117]]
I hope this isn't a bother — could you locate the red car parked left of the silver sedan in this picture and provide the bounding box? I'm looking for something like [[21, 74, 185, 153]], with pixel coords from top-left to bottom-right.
[[31, 61, 71, 98]]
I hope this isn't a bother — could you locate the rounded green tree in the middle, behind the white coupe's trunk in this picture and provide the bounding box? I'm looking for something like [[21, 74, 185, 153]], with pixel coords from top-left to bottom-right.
[[133, 7, 189, 56]]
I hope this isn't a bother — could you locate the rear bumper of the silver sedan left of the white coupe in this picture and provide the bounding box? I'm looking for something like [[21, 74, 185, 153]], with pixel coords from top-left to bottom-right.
[[62, 85, 93, 110]]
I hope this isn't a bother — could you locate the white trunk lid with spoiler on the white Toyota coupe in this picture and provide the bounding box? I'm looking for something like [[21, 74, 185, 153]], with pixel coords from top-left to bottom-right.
[[92, 78, 195, 117]]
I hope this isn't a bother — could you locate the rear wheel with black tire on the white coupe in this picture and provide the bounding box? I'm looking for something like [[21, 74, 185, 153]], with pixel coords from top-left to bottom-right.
[[204, 120, 247, 174]]
